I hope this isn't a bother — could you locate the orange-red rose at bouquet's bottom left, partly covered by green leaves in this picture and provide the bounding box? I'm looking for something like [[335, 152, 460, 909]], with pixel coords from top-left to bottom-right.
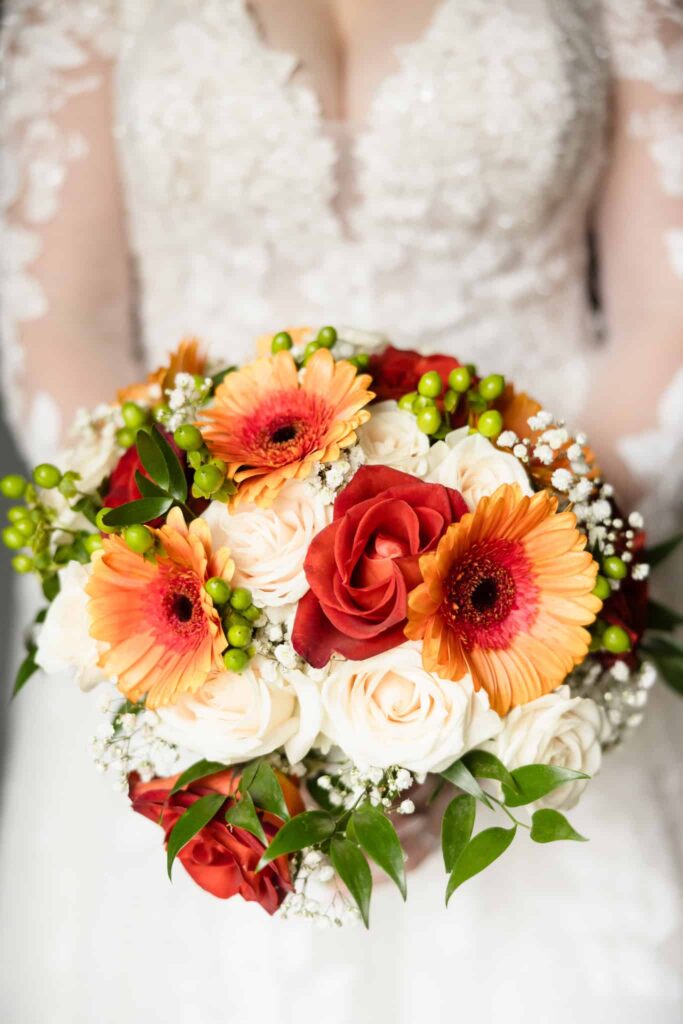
[[129, 771, 304, 913]]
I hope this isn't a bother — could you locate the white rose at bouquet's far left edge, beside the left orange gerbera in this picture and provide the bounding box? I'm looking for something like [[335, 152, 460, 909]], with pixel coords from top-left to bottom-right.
[[36, 562, 108, 690]]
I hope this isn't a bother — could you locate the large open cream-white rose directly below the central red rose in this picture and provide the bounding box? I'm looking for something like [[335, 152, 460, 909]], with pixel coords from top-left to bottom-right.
[[323, 644, 501, 772]]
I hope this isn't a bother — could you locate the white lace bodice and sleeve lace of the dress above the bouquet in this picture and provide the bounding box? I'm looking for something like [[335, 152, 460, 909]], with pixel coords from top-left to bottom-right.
[[4, 0, 683, 528]]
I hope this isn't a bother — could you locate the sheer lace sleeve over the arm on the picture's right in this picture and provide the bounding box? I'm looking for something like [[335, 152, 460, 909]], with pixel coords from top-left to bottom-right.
[[588, 0, 683, 531]]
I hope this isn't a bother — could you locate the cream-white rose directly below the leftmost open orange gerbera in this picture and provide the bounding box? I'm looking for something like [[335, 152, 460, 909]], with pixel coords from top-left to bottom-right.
[[157, 657, 322, 764]]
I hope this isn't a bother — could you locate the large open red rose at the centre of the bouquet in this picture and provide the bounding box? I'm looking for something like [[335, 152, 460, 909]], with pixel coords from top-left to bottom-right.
[[292, 466, 467, 668]]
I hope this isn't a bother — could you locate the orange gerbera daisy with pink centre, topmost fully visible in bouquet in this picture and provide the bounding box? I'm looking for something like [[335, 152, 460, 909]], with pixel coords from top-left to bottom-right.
[[200, 348, 374, 505]]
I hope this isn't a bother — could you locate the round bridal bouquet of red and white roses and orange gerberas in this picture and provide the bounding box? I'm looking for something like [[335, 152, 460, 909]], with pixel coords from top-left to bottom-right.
[[0, 327, 683, 925]]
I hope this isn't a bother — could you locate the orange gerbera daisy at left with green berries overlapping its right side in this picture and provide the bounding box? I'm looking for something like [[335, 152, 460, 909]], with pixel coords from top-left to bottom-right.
[[86, 509, 234, 708]]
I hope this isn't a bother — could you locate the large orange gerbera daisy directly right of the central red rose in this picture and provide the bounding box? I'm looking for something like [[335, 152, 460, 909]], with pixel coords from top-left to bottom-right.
[[405, 484, 602, 715]]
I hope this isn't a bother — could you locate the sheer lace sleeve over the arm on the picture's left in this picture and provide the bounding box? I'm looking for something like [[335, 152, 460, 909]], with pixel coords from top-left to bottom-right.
[[0, 0, 139, 461]]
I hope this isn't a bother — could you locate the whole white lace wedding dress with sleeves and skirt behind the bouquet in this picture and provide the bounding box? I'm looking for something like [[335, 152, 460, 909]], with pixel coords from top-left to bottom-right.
[[0, 0, 683, 1024]]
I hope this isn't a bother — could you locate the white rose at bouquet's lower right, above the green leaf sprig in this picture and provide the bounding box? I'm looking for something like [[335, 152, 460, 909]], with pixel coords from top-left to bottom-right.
[[488, 686, 604, 810]]
